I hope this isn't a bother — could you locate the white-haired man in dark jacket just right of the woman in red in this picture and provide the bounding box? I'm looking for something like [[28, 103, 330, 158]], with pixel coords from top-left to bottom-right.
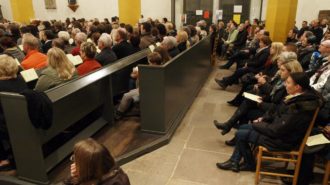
[[95, 33, 117, 66]]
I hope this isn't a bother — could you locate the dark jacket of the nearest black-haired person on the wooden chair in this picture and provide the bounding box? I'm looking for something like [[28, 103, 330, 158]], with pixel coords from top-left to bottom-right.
[[252, 90, 321, 150]]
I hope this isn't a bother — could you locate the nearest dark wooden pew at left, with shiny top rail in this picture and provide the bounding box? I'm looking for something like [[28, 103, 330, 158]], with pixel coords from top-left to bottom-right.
[[0, 49, 150, 184]]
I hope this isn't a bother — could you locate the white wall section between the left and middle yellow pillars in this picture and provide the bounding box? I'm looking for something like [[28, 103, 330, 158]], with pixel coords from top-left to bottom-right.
[[33, 0, 119, 20]]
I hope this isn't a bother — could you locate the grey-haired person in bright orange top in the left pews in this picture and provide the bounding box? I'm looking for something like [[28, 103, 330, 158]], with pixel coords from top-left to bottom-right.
[[21, 33, 47, 70]]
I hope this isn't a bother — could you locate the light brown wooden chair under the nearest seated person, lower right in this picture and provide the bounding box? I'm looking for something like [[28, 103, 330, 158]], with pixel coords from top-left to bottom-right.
[[255, 108, 319, 185]]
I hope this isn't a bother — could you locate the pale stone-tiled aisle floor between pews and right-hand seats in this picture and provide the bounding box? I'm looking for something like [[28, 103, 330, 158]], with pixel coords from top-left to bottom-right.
[[123, 62, 254, 185]]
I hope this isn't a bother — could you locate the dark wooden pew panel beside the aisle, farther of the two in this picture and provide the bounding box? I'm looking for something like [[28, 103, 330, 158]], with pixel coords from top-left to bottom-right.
[[139, 37, 212, 134]]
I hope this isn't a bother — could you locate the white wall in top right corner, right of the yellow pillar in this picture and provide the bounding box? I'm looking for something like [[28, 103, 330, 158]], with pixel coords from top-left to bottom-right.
[[296, 0, 330, 28]]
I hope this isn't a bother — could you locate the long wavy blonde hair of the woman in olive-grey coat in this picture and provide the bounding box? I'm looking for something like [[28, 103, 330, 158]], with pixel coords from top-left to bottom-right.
[[47, 47, 75, 80]]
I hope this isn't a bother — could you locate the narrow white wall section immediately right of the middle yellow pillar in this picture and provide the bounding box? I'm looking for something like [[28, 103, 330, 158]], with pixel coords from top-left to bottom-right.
[[141, 0, 171, 20]]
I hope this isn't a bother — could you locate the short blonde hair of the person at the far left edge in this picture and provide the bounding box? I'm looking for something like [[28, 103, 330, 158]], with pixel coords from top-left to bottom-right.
[[0, 54, 18, 79]]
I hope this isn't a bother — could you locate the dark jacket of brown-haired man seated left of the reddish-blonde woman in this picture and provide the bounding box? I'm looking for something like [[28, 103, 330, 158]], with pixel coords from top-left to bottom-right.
[[247, 47, 269, 73]]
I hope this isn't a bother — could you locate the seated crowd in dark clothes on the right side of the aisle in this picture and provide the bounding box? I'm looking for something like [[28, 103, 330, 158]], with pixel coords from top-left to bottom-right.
[[211, 19, 330, 185]]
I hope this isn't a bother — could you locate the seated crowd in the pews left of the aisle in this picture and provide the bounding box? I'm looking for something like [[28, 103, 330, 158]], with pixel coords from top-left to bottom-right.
[[0, 17, 211, 185]]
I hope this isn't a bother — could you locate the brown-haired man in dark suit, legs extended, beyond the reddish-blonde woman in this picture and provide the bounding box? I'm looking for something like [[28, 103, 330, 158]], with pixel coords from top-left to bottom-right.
[[215, 36, 272, 89]]
